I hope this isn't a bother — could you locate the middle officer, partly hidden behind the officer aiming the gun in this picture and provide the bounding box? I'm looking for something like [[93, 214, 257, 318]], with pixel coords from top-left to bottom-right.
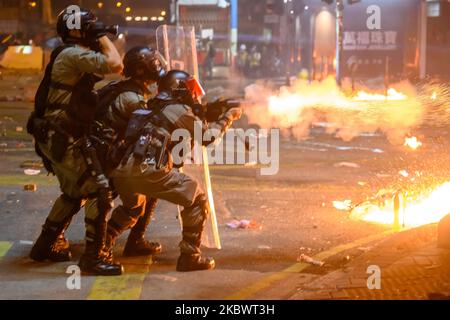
[[96, 46, 166, 257]]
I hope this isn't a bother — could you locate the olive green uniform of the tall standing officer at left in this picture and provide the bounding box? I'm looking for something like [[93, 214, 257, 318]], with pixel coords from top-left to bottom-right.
[[39, 46, 111, 240]]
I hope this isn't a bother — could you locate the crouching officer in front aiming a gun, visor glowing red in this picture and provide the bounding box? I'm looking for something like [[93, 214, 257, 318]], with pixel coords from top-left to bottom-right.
[[106, 71, 242, 272]]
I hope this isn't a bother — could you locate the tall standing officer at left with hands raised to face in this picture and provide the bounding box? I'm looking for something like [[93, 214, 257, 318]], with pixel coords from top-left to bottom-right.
[[28, 9, 123, 275]]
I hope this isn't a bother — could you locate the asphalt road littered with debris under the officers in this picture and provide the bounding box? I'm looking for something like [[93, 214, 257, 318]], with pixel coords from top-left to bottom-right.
[[0, 75, 450, 299]]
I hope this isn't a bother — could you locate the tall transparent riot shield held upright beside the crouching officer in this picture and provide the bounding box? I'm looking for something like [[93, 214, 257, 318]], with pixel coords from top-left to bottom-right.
[[156, 25, 222, 249]]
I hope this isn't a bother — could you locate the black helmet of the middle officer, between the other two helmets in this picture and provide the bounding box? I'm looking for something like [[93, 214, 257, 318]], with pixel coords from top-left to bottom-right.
[[123, 47, 166, 81]]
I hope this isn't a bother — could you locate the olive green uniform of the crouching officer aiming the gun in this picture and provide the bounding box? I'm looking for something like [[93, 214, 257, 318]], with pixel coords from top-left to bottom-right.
[[108, 104, 231, 255]]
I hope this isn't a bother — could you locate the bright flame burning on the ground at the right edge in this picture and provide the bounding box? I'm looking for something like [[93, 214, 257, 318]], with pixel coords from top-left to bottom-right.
[[352, 182, 450, 228]]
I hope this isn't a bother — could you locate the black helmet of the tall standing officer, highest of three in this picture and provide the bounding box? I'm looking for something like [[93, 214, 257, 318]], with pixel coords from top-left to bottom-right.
[[56, 6, 97, 43]]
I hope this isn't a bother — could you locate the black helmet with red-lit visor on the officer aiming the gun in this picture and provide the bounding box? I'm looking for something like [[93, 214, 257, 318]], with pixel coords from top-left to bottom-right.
[[158, 70, 205, 105]]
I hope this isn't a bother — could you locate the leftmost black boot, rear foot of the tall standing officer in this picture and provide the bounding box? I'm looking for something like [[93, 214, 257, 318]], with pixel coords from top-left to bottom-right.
[[30, 220, 72, 262]]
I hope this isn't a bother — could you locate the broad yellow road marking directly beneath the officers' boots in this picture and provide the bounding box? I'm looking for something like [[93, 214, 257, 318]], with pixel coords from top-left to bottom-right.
[[87, 257, 152, 300]]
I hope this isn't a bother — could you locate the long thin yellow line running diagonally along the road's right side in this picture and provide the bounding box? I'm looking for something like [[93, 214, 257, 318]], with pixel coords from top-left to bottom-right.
[[225, 230, 395, 300]]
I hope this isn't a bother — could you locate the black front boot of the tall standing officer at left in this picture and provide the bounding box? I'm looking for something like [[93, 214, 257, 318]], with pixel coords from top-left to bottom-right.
[[78, 241, 123, 276]]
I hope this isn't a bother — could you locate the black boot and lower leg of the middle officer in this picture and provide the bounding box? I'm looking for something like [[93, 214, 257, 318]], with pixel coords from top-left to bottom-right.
[[123, 199, 162, 257]]
